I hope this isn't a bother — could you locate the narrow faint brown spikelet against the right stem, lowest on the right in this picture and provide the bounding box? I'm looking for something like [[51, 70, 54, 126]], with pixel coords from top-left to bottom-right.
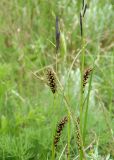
[[76, 117, 82, 151]]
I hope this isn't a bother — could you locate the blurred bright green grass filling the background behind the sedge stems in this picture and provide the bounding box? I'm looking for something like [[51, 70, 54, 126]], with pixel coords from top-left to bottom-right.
[[0, 0, 114, 160]]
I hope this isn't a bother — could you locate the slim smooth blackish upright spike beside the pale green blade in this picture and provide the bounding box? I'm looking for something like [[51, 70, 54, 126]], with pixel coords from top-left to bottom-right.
[[55, 16, 60, 53]]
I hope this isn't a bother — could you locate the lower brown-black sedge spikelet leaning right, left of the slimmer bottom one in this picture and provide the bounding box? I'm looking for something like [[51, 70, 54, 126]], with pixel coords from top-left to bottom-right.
[[54, 116, 68, 148]]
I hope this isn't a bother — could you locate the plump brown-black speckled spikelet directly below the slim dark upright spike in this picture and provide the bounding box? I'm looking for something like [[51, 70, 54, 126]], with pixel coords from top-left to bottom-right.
[[47, 68, 57, 94]]
